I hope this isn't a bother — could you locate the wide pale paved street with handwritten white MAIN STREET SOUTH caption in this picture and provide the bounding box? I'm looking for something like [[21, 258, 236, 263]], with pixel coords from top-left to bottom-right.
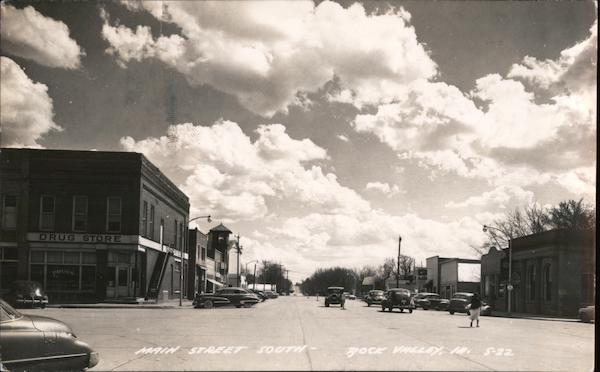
[[24, 297, 594, 371]]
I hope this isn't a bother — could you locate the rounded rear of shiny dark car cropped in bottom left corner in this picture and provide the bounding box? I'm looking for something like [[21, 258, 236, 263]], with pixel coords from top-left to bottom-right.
[[0, 300, 99, 371]]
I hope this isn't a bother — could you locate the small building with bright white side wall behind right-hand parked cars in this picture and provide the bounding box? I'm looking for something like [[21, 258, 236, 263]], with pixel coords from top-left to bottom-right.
[[424, 256, 481, 298]]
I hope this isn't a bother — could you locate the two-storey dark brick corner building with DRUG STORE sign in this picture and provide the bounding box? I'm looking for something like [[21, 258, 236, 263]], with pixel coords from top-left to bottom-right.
[[0, 149, 189, 302]]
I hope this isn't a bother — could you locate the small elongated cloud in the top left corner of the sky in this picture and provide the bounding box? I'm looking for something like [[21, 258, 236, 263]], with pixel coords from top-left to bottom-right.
[[0, 2, 84, 69]]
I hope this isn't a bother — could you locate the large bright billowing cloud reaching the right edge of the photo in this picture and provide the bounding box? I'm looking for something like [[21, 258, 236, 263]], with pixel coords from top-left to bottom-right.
[[352, 18, 597, 198]]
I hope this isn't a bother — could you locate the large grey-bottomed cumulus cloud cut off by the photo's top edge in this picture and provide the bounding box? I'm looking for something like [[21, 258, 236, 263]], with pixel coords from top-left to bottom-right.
[[102, 1, 437, 116]]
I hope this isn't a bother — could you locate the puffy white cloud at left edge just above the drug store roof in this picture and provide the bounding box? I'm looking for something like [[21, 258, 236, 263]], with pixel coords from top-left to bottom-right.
[[0, 57, 62, 147]]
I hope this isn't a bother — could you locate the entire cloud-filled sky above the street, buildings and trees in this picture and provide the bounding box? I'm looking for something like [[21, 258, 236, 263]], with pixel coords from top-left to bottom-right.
[[0, 1, 597, 281]]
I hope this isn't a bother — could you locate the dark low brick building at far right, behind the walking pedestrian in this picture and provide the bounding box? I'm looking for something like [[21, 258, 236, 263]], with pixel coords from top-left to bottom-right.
[[481, 230, 596, 316]]
